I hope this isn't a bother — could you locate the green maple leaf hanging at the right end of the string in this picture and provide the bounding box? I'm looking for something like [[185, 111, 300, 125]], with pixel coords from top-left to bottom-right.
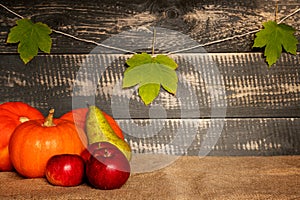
[[253, 21, 298, 66]]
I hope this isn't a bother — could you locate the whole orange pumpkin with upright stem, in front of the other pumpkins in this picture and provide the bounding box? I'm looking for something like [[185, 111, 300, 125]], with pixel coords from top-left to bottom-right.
[[9, 109, 87, 178]]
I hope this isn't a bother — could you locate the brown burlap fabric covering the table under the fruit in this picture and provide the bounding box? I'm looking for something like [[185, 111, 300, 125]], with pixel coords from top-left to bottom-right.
[[0, 156, 300, 200]]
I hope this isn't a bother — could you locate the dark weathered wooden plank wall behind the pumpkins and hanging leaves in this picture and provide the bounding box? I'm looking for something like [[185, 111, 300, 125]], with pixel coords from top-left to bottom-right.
[[0, 0, 300, 155]]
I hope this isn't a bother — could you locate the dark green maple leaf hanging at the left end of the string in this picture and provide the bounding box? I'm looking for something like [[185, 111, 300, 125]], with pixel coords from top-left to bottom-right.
[[7, 19, 52, 64]]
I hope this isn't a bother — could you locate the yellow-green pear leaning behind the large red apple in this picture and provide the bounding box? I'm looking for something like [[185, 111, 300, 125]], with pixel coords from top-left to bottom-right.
[[86, 105, 131, 161]]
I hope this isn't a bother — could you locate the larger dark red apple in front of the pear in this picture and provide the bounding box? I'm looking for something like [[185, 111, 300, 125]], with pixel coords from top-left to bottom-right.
[[86, 143, 130, 190]]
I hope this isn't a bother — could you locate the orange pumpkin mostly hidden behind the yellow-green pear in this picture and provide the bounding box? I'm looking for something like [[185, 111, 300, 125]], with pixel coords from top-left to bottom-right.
[[60, 108, 124, 140]]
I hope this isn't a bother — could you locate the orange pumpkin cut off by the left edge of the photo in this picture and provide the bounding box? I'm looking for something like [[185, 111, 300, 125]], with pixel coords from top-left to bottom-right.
[[0, 102, 44, 171]]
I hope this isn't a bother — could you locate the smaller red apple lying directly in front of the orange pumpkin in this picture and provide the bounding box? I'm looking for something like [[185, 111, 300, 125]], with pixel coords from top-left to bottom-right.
[[45, 154, 85, 186]]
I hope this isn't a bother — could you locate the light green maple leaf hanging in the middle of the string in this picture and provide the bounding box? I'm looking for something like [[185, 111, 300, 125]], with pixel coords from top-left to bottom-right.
[[123, 53, 178, 105]]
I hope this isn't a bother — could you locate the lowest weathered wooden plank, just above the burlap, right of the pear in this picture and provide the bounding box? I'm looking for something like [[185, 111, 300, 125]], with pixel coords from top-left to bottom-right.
[[118, 118, 300, 156]]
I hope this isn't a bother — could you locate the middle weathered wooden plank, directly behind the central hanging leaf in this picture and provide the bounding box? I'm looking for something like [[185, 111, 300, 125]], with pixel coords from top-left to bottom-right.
[[0, 53, 300, 119]]
